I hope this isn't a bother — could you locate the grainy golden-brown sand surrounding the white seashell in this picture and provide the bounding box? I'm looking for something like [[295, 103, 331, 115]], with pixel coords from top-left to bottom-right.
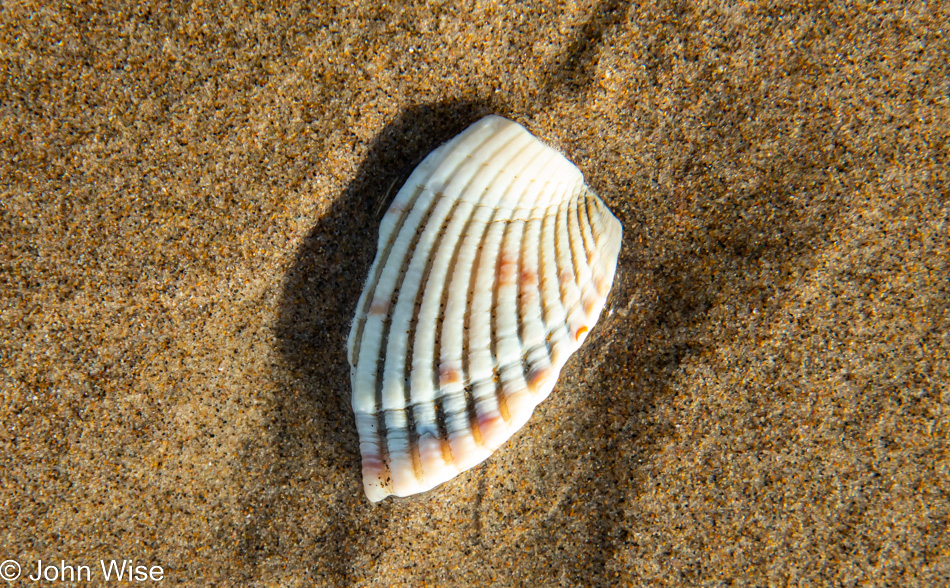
[[0, 1, 950, 586]]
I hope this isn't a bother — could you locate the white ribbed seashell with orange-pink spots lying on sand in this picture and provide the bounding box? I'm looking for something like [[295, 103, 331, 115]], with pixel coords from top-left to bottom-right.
[[348, 116, 622, 502]]
